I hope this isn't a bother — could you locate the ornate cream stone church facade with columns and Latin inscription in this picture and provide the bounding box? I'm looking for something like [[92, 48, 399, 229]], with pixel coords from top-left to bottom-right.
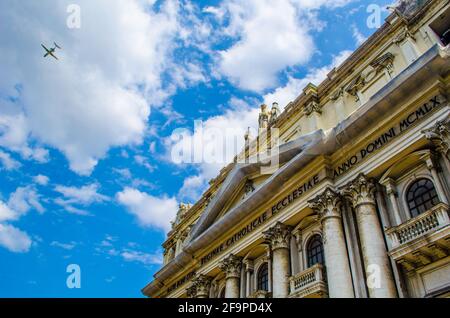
[[142, 0, 450, 298]]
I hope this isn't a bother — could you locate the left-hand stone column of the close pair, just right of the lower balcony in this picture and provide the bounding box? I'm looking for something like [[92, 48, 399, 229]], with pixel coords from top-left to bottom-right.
[[309, 188, 355, 298]]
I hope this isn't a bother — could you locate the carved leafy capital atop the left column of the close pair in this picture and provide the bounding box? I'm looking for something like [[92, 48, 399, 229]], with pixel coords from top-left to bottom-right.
[[308, 187, 342, 221]]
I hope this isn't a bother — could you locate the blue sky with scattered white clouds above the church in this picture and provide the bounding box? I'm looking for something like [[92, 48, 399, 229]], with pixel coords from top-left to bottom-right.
[[0, 0, 392, 297]]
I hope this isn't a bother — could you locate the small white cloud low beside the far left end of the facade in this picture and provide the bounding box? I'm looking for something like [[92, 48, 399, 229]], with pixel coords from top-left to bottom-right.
[[116, 188, 178, 232]]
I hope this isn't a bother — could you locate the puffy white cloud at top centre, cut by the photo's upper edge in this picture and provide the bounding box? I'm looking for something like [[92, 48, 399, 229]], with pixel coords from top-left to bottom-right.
[[219, 0, 314, 91]]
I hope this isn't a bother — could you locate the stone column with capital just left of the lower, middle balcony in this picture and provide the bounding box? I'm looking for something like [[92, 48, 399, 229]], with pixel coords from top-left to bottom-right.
[[263, 222, 291, 298]]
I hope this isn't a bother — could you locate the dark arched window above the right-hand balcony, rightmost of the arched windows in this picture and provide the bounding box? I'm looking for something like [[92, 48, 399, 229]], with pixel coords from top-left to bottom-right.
[[406, 179, 439, 218]]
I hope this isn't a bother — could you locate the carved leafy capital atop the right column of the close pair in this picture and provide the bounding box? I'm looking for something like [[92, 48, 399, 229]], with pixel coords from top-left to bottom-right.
[[342, 173, 376, 208]]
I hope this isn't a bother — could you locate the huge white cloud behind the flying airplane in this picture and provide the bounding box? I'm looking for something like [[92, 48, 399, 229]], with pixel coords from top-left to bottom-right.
[[0, 0, 203, 175]]
